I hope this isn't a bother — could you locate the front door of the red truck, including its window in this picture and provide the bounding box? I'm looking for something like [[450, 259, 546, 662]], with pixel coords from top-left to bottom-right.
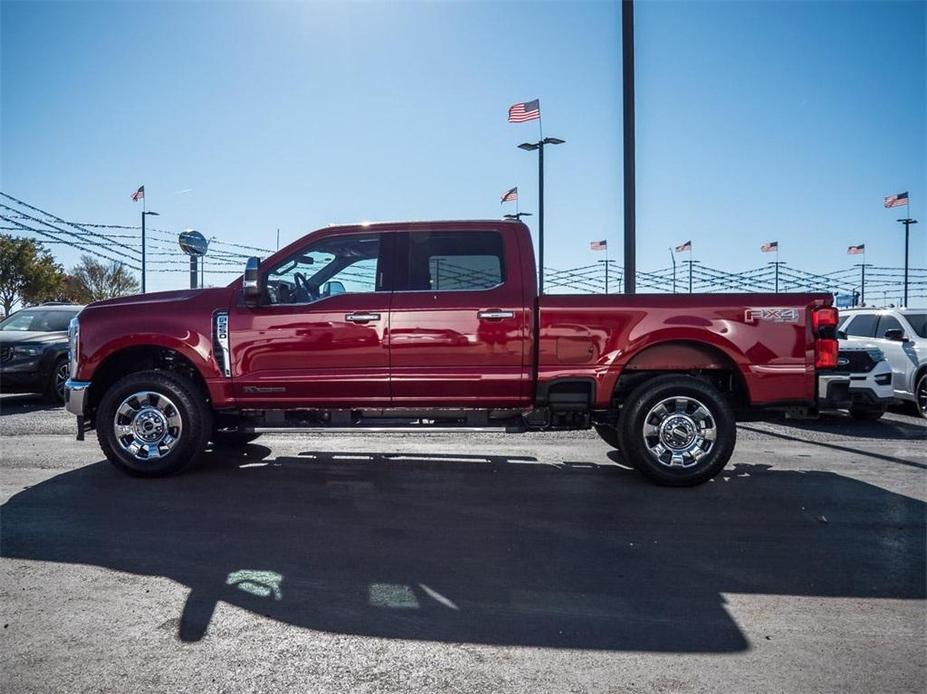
[[230, 233, 390, 407]]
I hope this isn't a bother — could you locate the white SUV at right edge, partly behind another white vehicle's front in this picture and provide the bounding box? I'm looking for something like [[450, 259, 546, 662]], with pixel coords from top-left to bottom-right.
[[838, 308, 927, 418]]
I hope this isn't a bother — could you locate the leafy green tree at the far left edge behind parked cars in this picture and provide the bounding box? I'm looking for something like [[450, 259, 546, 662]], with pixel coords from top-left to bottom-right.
[[0, 234, 64, 316]]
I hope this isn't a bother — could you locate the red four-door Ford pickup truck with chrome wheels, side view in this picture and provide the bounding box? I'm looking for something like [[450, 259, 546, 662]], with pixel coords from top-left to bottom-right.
[[61, 221, 837, 486]]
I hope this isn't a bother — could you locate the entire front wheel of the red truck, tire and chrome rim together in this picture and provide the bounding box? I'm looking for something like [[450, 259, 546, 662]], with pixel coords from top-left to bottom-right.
[[96, 371, 212, 477]]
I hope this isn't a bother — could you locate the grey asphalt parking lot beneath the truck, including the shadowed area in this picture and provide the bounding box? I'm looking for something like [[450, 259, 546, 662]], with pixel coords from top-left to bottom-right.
[[0, 396, 927, 693]]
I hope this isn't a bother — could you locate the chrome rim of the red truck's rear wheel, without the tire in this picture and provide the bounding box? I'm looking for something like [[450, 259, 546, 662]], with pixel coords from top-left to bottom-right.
[[643, 396, 718, 469]]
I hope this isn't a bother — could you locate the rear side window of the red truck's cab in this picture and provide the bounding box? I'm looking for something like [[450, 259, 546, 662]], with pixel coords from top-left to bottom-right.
[[408, 231, 505, 291]]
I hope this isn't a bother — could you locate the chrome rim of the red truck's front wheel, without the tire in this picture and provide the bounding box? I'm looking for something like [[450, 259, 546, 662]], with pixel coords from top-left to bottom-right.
[[113, 390, 183, 461]]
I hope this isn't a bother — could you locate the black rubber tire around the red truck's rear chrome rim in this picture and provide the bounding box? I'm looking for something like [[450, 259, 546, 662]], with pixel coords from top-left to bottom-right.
[[618, 374, 737, 487]]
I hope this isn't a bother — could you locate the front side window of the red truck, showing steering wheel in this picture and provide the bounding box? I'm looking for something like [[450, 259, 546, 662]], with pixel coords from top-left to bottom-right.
[[266, 234, 382, 304]]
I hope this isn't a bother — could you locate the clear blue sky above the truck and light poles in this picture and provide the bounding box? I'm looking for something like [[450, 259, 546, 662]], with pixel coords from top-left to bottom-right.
[[0, 1, 927, 288]]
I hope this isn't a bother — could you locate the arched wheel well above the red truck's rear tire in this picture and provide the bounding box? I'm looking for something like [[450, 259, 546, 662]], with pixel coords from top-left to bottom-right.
[[612, 341, 750, 407]]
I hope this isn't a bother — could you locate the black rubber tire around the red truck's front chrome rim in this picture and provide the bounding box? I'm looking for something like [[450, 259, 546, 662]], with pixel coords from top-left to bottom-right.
[[96, 371, 212, 477]]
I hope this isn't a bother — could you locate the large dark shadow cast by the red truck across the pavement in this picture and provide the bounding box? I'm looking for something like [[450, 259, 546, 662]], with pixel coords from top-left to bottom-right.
[[0, 445, 925, 652]]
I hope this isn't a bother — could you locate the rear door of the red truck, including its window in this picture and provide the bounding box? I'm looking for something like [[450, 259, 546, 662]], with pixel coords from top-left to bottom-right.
[[389, 230, 531, 407]]
